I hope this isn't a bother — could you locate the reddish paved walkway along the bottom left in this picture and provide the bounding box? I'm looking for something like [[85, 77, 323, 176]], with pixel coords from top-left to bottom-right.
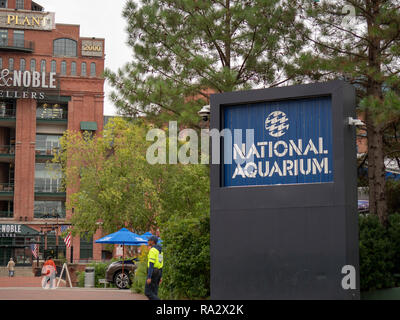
[[0, 277, 147, 300]]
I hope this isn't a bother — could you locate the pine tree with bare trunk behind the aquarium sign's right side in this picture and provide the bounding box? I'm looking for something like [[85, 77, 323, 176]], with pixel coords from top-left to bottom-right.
[[290, 0, 400, 225]]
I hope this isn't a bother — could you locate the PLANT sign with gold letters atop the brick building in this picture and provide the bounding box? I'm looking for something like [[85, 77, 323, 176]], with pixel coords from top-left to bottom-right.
[[0, 10, 56, 31]]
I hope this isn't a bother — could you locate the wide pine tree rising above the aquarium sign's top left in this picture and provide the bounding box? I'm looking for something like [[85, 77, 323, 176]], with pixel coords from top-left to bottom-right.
[[105, 0, 301, 128]]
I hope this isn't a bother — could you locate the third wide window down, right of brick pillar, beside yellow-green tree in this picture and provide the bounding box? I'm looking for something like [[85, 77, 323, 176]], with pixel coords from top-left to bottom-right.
[[35, 163, 62, 193]]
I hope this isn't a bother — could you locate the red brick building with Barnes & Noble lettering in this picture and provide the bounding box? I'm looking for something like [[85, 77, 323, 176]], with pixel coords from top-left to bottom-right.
[[0, 0, 104, 265]]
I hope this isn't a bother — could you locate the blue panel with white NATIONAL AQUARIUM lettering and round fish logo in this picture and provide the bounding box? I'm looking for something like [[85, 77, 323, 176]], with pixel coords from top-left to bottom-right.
[[223, 96, 333, 187]]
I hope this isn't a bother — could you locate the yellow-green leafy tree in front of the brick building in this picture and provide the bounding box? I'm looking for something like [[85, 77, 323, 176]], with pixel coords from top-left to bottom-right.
[[53, 119, 160, 236]]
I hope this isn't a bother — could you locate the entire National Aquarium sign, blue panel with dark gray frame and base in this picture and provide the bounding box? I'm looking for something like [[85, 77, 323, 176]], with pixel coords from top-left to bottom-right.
[[210, 81, 360, 300]]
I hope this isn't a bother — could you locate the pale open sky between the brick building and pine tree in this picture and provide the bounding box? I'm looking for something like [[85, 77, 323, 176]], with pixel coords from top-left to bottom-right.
[[35, 0, 132, 115]]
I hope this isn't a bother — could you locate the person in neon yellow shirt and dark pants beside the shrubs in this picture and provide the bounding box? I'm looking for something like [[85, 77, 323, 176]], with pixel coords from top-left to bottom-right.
[[144, 236, 163, 300]]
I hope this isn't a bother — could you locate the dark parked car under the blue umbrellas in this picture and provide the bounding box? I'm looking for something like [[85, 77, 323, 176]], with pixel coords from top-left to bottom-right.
[[106, 259, 137, 289]]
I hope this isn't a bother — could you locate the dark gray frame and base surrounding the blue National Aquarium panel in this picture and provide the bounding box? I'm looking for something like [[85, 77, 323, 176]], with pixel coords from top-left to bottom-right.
[[210, 80, 360, 299]]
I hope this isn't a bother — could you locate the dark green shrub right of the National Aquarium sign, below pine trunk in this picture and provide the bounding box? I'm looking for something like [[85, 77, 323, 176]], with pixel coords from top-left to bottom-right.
[[359, 215, 395, 291]]
